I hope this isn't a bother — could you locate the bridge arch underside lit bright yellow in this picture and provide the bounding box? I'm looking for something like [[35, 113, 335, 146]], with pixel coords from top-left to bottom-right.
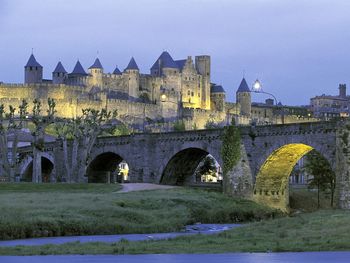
[[253, 143, 334, 211]]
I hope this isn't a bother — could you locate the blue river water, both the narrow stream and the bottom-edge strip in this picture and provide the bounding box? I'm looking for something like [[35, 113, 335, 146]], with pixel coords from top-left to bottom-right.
[[0, 224, 350, 263]]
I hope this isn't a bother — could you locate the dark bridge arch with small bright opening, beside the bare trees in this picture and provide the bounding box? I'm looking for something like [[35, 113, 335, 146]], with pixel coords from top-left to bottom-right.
[[86, 151, 130, 183]]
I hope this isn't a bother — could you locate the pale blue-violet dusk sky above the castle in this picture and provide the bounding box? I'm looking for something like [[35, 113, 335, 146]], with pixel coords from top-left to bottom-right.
[[0, 0, 350, 105]]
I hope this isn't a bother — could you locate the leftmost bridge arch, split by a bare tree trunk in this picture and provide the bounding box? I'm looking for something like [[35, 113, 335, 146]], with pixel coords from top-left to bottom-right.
[[19, 152, 56, 183]]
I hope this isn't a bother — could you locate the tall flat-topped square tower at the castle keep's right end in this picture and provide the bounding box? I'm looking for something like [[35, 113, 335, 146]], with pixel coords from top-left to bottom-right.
[[195, 56, 210, 109]]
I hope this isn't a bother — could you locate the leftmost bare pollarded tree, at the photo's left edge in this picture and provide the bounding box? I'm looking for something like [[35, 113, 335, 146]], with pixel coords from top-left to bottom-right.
[[0, 100, 28, 182]]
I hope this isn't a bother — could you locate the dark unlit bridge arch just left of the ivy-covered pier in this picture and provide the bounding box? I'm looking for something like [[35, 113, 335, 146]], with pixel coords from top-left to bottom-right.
[[160, 147, 221, 185]]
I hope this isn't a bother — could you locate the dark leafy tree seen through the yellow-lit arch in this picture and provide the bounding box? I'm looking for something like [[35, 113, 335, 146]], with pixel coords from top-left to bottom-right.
[[304, 150, 335, 208]]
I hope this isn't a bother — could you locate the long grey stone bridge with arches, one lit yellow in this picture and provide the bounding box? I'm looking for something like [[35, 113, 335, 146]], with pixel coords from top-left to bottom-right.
[[14, 121, 350, 210]]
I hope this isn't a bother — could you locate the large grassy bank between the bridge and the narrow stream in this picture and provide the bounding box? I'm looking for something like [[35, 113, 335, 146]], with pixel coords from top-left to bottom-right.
[[0, 183, 278, 240]]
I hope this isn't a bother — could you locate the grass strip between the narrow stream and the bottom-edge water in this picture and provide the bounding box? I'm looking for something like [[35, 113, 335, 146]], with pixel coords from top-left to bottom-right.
[[0, 210, 350, 255]]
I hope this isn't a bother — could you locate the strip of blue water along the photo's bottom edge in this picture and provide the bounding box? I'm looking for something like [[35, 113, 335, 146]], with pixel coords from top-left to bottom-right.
[[0, 252, 350, 263]]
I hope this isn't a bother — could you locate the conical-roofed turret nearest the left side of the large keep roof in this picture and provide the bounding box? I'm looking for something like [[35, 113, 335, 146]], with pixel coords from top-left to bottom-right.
[[124, 58, 140, 100]]
